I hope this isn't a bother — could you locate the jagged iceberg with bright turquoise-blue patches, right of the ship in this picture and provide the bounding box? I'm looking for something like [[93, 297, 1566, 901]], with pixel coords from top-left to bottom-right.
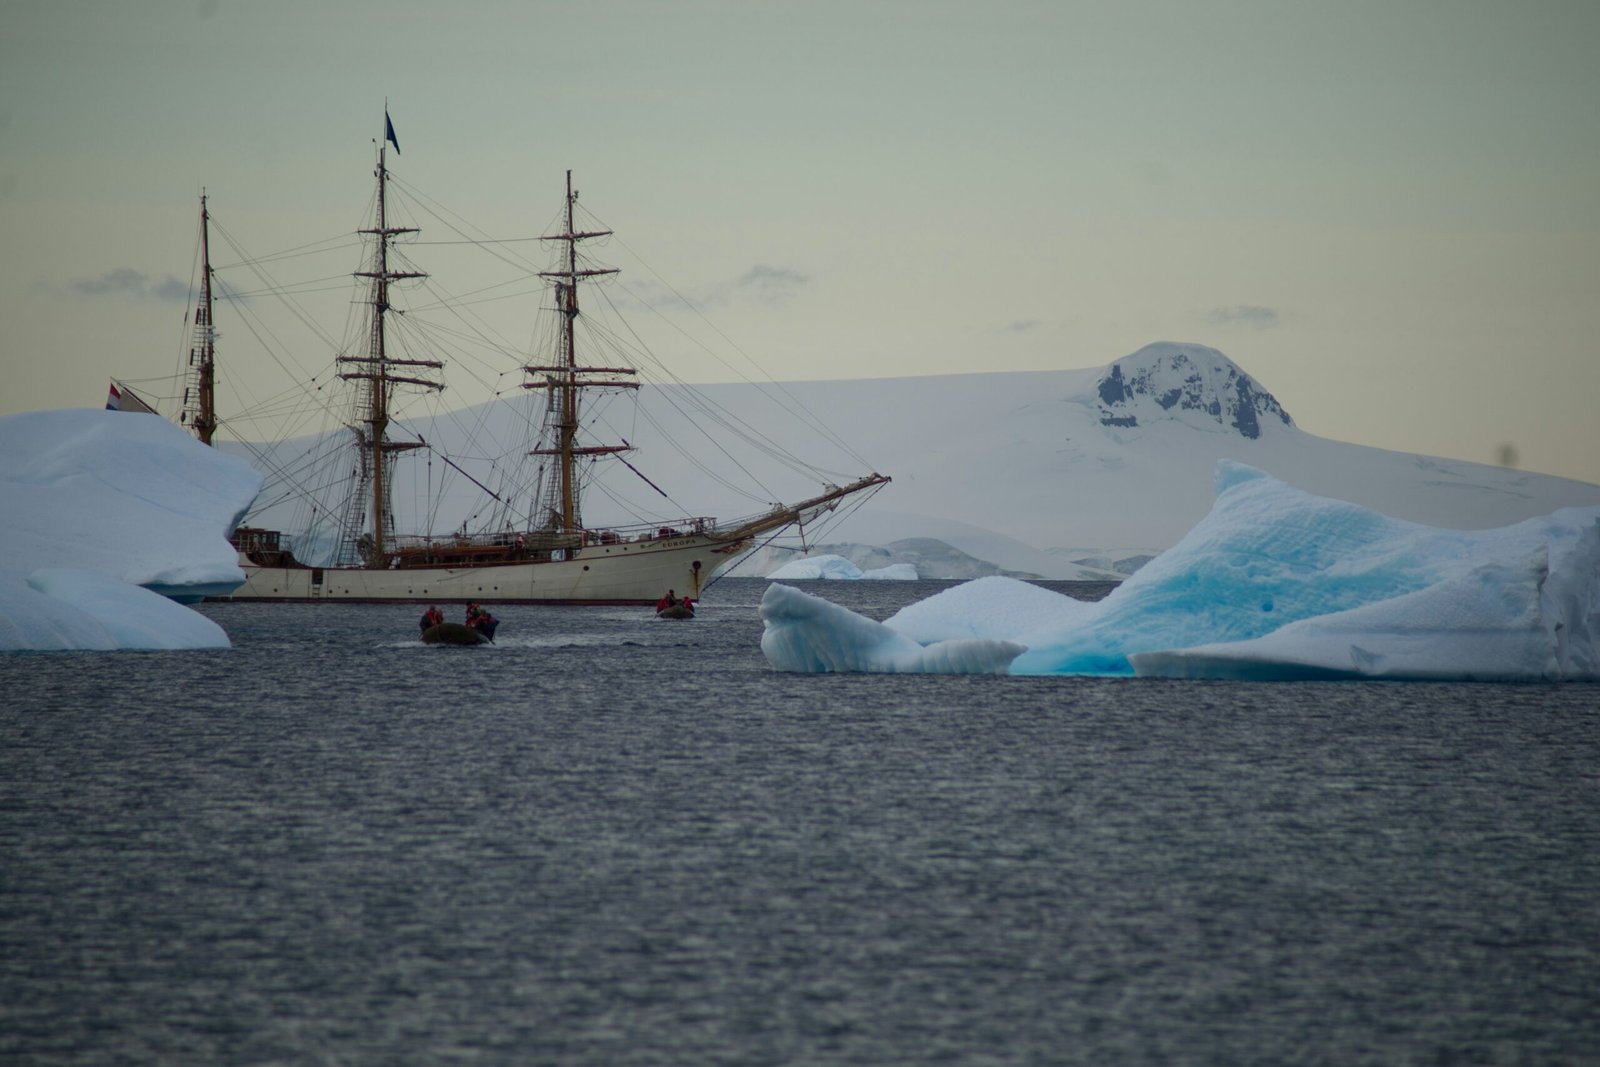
[[762, 461, 1600, 681]]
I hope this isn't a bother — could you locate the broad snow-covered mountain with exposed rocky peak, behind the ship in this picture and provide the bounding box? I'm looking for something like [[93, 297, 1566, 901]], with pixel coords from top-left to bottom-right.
[[233, 342, 1600, 577]]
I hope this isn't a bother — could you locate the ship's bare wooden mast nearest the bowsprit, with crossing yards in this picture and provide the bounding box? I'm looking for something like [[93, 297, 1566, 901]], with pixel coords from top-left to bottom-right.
[[523, 171, 638, 533]]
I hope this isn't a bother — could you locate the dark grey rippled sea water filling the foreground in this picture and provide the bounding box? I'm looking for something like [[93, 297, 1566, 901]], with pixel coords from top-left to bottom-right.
[[0, 581, 1600, 1064]]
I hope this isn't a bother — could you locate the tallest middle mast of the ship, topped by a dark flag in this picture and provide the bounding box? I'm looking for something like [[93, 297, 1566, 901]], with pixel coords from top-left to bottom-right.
[[338, 114, 445, 568]]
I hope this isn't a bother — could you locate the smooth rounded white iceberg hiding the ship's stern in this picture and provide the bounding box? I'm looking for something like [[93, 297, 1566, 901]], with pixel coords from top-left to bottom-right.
[[0, 410, 261, 651]]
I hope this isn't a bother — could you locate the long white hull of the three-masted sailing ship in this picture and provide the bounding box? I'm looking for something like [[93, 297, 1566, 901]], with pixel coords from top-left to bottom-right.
[[227, 534, 749, 605]]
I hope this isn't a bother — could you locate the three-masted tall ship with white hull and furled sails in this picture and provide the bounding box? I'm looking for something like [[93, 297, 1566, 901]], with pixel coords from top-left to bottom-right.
[[137, 115, 890, 605]]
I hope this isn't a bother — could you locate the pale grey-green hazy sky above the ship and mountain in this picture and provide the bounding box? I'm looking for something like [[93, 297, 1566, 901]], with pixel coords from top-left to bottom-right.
[[0, 0, 1600, 483]]
